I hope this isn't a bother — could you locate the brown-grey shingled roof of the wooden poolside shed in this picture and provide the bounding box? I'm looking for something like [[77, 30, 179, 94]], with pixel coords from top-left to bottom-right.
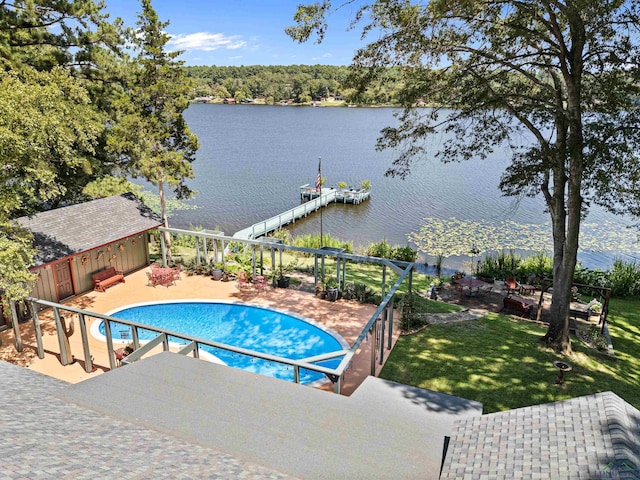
[[15, 193, 162, 265]]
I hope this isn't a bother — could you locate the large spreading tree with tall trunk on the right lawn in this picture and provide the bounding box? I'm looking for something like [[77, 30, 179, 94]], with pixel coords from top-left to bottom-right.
[[287, 0, 640, 353]]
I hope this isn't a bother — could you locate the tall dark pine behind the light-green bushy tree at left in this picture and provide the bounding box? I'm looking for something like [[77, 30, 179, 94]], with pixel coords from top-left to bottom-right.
[[0, 0, 123, 208]]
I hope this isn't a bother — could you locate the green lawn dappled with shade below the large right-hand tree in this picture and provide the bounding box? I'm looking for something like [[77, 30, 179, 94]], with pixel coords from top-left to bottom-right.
[[380, 299, 640, 413]]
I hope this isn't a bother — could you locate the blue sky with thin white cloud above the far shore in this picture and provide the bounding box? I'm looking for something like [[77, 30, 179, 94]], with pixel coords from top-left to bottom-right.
[[105, 0, 364, 66]]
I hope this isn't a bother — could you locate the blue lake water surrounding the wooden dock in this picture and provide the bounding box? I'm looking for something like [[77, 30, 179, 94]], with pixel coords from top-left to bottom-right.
[[154, 104, 635, 267]]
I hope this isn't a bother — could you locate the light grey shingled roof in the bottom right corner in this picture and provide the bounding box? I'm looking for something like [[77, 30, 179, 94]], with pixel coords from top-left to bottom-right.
[[441, 392, 640, 480]]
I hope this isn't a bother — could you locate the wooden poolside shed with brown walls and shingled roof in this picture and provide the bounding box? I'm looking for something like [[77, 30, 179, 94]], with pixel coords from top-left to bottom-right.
[[15, 193, 162, 302]]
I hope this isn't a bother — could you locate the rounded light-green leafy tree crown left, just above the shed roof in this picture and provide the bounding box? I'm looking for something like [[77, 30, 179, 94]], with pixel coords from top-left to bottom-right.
[[0, 67, 104, 218]]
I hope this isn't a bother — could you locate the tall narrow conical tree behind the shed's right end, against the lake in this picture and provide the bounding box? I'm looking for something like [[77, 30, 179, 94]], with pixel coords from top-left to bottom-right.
[[109, 0, 198, 257]]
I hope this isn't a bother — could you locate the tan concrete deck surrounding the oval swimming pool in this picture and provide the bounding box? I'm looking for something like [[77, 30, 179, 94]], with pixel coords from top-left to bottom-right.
[[0, 268, 398, 395]]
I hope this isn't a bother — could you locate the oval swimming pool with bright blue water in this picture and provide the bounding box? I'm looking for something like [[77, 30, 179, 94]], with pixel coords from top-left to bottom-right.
[[91, 300, 349, 383]]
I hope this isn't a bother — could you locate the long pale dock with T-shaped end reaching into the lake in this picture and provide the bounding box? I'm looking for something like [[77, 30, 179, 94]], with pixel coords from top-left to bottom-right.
[[233, 184, 371, 240]]
